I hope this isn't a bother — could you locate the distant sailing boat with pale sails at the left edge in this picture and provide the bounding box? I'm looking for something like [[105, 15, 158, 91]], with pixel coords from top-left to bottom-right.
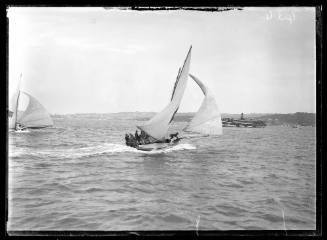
[[8, 75, 53, 131]]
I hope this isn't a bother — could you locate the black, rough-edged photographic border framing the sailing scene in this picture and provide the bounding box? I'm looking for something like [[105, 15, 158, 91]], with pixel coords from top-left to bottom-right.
[[1, 1, 327, 239]]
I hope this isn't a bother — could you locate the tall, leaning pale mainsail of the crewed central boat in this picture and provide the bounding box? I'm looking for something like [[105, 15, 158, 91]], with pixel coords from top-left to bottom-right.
[[137, 46, 192, 140]]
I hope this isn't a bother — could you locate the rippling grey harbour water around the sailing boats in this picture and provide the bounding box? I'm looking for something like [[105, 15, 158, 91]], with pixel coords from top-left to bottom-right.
[[7, 114, 316, 231]]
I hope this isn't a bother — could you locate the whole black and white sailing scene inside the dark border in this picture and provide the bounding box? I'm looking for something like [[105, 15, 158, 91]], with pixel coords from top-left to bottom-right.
[[6, 6, 320, 235]]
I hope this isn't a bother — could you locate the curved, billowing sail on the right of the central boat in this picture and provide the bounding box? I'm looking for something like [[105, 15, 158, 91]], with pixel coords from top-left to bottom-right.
[[184, 74, 223, 135]]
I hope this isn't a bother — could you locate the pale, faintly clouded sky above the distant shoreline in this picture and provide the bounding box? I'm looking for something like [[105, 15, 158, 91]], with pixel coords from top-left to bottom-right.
[[7, 7, 316, 114]]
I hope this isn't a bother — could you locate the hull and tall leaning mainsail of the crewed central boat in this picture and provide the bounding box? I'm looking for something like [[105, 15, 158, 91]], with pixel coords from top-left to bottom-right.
[[125, 46, 192, 151]]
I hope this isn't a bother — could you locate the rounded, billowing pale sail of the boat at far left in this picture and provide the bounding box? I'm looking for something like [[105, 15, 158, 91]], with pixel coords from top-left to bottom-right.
[[17, 92, 53, 128]]
